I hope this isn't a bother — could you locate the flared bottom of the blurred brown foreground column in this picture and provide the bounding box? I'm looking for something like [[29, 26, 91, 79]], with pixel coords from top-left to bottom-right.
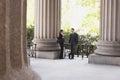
[[0, 68, 41, 80]]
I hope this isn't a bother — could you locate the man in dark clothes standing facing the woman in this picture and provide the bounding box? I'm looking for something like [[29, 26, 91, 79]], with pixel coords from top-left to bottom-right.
[[69, 28, 78, 59]]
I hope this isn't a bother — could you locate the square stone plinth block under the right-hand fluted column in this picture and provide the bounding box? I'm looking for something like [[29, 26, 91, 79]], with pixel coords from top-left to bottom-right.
[[88, 54, 120, 66]]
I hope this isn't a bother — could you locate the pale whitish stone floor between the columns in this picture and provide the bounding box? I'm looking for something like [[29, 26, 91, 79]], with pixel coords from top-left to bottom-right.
[[30, 58, 120, 80]]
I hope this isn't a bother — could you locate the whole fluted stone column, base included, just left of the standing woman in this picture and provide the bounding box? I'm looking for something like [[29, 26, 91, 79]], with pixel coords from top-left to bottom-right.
[[33, 0, 61, 59]]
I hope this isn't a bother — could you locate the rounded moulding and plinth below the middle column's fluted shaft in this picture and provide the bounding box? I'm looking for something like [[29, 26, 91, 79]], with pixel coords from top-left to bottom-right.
[[33, 39, 60, 59]]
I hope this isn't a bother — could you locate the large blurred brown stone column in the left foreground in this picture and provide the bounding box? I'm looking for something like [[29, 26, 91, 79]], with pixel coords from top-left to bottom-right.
[[0, 0, 40, 80]]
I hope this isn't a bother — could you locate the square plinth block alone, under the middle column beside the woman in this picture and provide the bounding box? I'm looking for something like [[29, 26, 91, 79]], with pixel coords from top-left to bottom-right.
[[36, 51, 60, 59]]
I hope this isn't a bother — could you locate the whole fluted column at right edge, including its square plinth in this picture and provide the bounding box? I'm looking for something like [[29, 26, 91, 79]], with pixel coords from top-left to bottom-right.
[[89, 0, 120, 65]]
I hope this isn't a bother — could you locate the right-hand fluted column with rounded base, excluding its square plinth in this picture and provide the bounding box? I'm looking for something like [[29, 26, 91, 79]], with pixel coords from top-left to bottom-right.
[[96, 0, 120, 56]]
